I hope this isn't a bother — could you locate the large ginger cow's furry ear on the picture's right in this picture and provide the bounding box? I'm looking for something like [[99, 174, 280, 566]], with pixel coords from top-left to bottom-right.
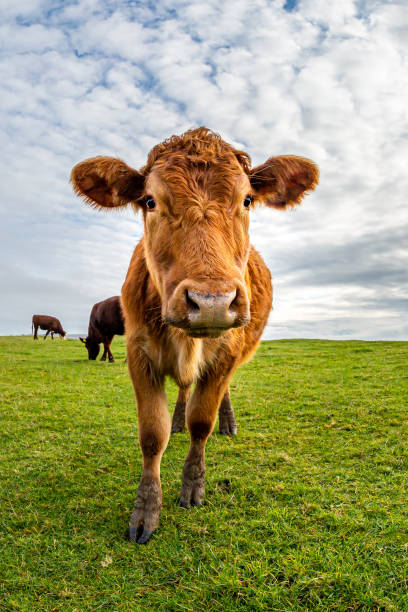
[[249, 155, 319, 209]]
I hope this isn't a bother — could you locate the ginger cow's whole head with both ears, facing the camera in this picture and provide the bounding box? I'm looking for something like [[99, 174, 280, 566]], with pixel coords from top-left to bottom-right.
[[71, 128, 318, 337]]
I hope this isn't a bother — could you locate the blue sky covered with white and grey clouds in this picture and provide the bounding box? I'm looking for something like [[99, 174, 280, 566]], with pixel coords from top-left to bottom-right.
[[0, 0, 408, 340]]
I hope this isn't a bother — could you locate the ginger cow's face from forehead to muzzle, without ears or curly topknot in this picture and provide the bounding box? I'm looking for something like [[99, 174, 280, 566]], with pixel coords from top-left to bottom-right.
[[142, 154, 252, 337]]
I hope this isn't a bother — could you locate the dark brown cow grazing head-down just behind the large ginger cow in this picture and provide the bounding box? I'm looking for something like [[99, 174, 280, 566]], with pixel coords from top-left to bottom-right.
[[80, 295, 125, 362]]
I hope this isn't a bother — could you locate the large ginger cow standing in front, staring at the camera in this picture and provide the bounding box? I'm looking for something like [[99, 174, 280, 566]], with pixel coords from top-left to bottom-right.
[[71, 128, 318, 544]]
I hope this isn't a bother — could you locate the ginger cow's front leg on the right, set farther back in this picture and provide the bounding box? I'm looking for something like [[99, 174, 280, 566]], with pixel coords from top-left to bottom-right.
[[180, 380, 226, 508]]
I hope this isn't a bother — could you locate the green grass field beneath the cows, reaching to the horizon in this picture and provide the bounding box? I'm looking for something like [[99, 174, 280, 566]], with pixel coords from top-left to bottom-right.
[[0, 337, 408, 611]]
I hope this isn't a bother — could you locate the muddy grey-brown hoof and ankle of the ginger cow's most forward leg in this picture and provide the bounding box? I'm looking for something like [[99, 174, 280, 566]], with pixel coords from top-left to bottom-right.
[[128, 478, 162, 544]]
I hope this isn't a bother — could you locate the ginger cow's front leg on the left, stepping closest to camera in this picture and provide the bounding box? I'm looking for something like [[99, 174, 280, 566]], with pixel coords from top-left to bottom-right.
[[128, 352, 170, 544]]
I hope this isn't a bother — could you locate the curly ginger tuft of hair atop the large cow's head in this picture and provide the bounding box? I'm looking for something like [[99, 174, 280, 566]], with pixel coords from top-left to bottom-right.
[[142, 127, 251, 174]]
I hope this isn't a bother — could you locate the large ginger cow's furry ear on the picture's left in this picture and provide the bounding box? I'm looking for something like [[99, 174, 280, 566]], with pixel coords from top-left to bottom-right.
[[71, 157, 145, 208]]
